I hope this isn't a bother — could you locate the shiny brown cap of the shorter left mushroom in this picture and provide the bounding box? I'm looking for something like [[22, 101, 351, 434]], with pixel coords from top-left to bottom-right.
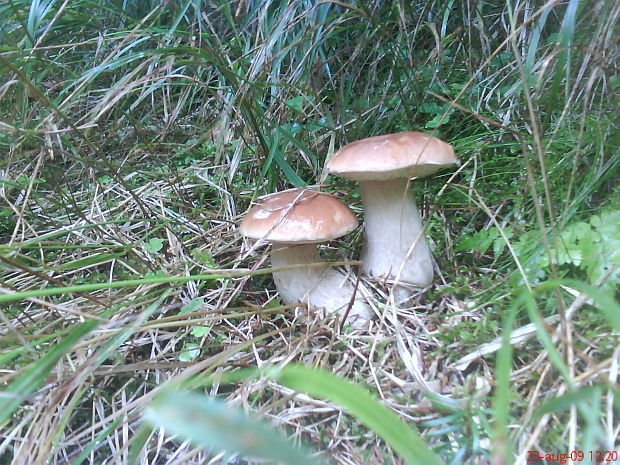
[[240, 189, 358, 244]]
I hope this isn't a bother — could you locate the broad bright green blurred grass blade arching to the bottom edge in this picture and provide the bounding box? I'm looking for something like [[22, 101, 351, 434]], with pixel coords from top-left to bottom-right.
[[268, 365, 443, 465]]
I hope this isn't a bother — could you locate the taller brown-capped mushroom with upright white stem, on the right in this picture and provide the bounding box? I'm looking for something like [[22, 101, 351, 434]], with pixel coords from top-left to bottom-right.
[[326, 132, 458, 302]]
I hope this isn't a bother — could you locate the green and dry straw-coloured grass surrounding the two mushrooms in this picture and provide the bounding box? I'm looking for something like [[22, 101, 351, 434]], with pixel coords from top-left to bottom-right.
[[0, 0, 620, 464]]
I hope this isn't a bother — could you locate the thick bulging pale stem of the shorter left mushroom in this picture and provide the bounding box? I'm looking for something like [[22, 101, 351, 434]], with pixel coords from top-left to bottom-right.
[[271, 243, 372, 328]]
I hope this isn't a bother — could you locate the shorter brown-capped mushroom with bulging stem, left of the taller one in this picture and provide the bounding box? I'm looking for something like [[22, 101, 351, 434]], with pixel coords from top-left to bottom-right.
[[240, 189, 372, 328]]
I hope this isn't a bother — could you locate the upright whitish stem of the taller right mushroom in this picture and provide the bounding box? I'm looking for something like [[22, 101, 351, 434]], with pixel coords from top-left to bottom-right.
[[360, 178, 433, 302]]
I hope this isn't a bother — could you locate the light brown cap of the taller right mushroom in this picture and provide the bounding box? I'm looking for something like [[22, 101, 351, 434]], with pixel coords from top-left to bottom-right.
[[326, 131, 458, 181]]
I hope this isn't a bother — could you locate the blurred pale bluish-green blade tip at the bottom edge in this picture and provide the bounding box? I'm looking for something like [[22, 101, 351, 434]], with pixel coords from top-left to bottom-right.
[[144, 391, 319, 465]]
